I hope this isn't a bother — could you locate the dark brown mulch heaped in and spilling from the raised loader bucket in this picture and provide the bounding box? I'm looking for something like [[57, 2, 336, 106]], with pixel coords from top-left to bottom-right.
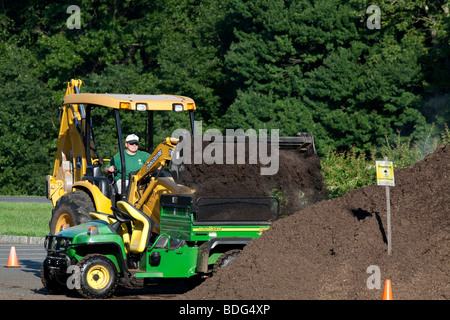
[[182, 142, 328, 215]]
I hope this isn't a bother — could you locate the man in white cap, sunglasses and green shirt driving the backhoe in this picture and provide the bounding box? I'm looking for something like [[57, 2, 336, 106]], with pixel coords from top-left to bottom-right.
[[105, 134, 150, 194]]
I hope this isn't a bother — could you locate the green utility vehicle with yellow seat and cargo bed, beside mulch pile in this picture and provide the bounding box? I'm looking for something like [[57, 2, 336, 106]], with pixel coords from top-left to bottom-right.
[[41, 194, 279, 298]]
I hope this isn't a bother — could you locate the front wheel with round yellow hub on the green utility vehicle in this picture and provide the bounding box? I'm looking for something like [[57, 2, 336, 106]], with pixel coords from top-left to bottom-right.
[[77, 254, 119, 299]]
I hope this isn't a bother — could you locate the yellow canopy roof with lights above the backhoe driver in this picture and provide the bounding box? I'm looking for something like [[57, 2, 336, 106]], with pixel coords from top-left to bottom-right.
[[63, 93, 196, 111]]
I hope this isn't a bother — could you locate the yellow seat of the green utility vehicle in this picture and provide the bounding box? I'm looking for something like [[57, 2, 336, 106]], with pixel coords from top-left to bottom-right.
[[116, 201, 154, 253]]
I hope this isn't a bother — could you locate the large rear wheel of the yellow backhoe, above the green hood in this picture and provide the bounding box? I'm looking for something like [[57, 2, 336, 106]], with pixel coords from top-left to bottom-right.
[[49, 191, 95, 234]]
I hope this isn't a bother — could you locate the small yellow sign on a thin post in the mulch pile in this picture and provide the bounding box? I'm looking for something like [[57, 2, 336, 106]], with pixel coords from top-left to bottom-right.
[[376, 157, 395, 256]]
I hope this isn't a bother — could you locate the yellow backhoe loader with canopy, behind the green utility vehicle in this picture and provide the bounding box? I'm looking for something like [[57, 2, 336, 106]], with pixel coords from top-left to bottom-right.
[[46, 80, 315, 234]]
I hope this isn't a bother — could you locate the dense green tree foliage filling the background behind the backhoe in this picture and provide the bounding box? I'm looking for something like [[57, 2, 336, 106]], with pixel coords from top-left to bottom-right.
[[0, 0, 450, 195]]
